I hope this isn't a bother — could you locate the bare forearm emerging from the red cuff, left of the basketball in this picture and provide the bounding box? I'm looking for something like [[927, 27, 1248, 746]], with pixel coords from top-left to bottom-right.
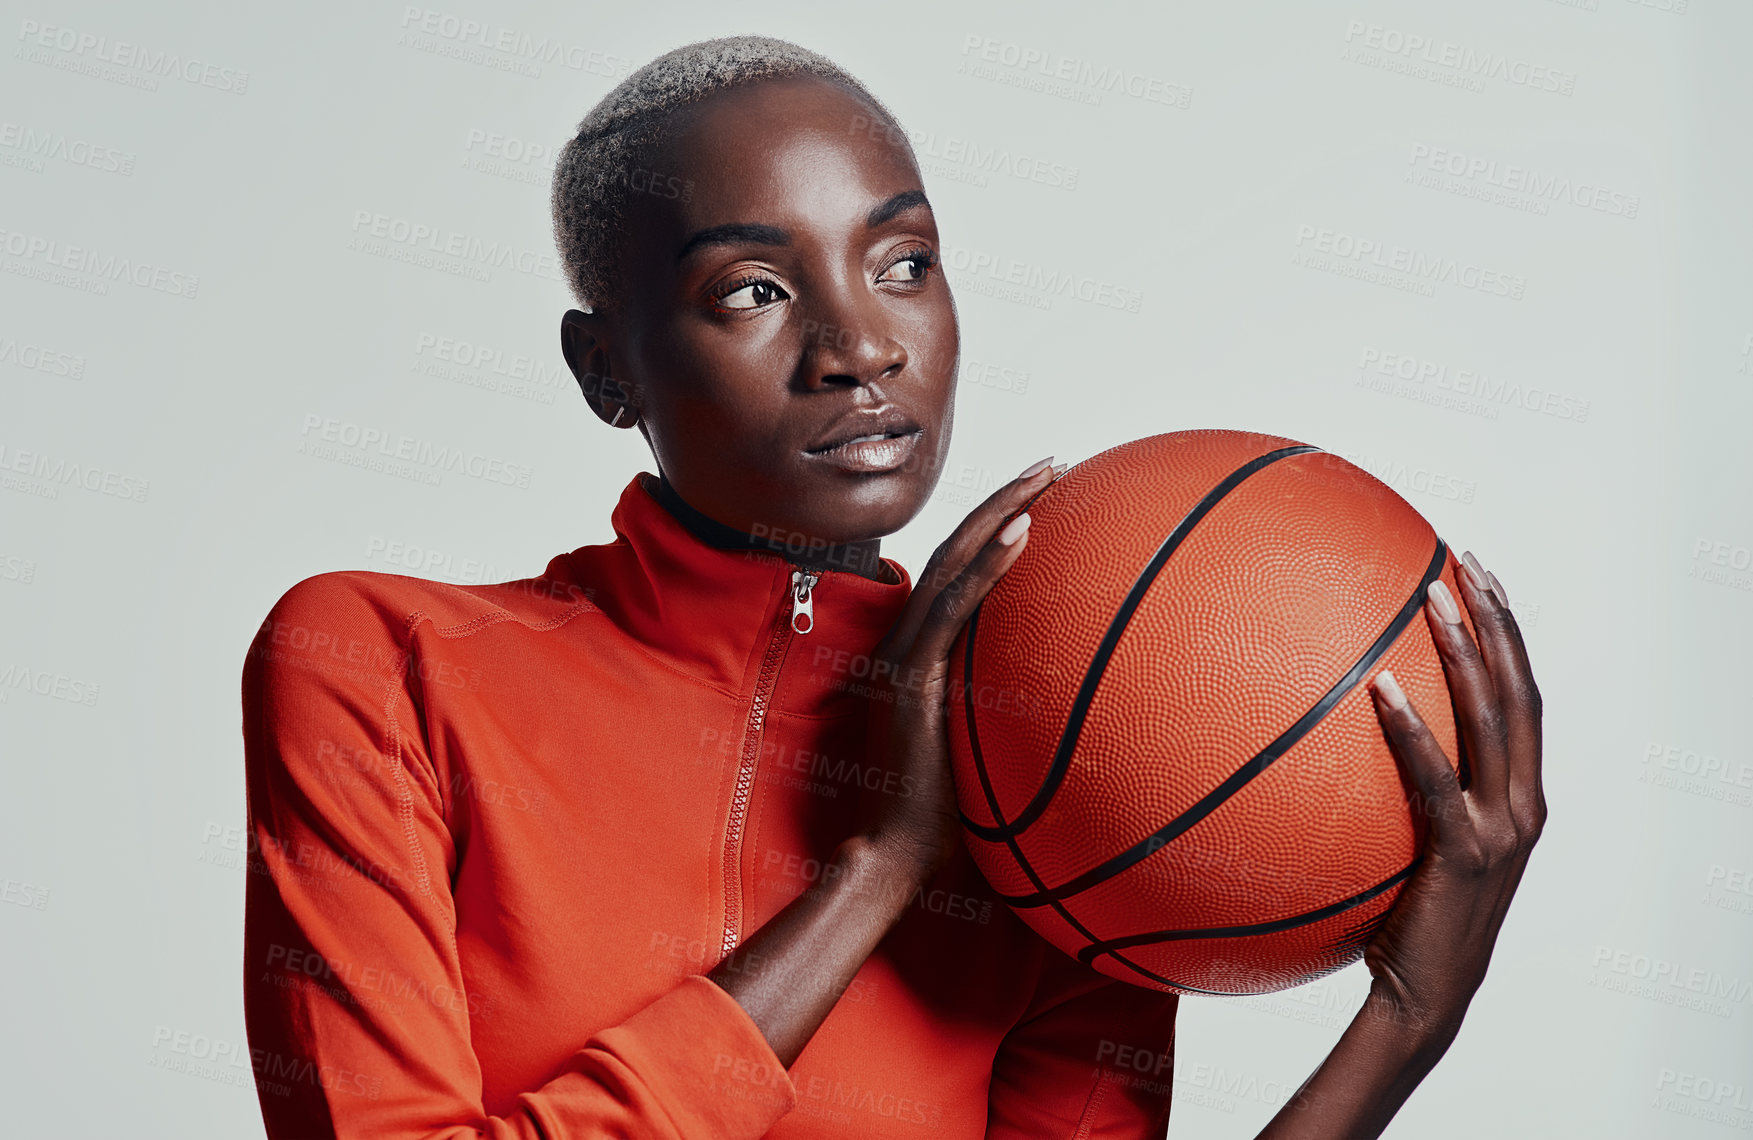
[[706, 837, 919, 1068]]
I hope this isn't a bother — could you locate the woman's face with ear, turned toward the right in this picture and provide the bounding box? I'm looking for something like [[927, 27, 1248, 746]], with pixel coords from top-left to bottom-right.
[[566, 79, 959, 542]]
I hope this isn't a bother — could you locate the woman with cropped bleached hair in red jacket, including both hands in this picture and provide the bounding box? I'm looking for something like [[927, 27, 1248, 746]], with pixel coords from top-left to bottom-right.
[[244, 37, 1544, 1140]]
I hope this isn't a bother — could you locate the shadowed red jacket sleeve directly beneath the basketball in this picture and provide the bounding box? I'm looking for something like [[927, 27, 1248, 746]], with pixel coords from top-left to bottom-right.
[[987, 945, 1180, 1140]]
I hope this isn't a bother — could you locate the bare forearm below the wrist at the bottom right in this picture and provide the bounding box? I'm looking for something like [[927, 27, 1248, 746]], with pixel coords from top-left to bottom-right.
[[1260, 989, 1460, 1140]]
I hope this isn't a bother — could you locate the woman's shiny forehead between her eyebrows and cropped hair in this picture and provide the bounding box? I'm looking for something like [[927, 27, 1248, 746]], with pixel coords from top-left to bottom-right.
[[636, 75, 920, 246]]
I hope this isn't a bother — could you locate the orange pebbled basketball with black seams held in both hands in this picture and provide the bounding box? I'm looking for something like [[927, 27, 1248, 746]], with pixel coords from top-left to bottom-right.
[[947, 430, 1471, 994]]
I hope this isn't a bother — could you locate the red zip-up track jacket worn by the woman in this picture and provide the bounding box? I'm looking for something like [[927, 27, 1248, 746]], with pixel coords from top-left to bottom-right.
[[244, 474, 1176, 1140]]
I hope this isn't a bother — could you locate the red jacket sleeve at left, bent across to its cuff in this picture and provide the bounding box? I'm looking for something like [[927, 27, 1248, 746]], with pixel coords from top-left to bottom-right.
[[244, 574, 796, 1140]]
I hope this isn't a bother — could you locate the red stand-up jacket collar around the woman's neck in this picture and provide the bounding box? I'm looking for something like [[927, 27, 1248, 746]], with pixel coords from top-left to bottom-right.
[[547, 472, 912, 705]]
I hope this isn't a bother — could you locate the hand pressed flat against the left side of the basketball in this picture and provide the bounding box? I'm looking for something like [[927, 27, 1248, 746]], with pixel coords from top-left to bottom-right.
[[866, 456, 1064, 882]]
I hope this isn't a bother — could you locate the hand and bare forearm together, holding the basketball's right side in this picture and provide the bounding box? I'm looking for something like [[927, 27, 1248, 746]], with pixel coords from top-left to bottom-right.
[[1260, 554, 1546, 1140]]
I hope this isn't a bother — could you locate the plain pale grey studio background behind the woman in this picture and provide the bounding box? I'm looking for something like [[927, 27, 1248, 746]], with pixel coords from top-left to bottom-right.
[[0, 0, 1753, 1138]]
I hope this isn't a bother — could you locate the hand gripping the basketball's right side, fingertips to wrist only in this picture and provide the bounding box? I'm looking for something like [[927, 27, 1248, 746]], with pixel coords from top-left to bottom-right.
[[1364, 554, 1546, 1040]]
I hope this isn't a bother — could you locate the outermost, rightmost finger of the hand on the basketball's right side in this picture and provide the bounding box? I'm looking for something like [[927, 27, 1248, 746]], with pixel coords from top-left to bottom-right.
[[1458, 551, 1546, 837]]
